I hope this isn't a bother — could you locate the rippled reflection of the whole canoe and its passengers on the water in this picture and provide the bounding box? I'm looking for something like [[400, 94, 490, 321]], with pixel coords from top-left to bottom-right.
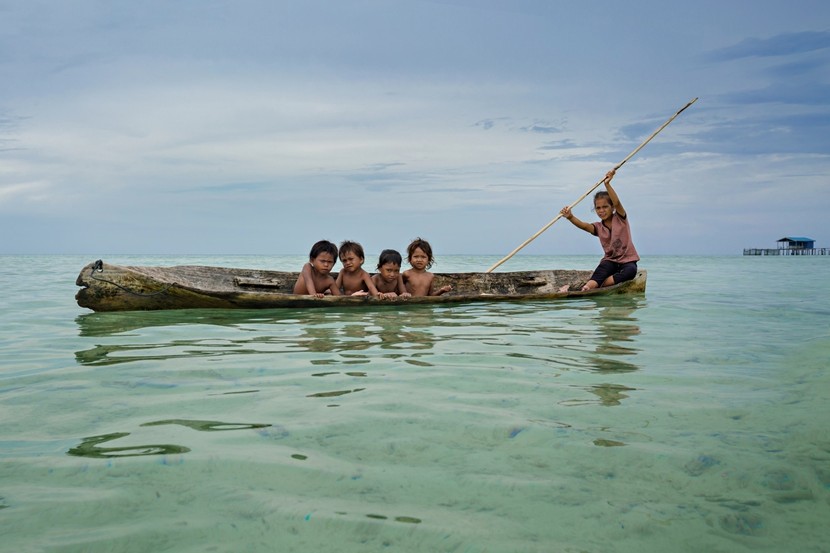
[[75, 296, 645, 406]]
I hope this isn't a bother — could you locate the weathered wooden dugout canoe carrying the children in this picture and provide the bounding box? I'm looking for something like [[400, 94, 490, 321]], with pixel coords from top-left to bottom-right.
[[75, 260, 646, 311]]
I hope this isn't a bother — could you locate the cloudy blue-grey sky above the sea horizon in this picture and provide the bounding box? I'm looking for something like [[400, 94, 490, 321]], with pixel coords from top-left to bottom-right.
[[0, 0, 830, 258]]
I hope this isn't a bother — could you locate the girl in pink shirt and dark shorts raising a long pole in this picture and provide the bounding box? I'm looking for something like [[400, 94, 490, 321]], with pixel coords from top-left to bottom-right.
[[561, 170, 640, 292]]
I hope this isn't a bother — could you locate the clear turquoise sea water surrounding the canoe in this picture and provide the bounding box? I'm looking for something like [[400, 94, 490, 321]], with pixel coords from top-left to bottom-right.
[[0, 256, 830, 553]]
